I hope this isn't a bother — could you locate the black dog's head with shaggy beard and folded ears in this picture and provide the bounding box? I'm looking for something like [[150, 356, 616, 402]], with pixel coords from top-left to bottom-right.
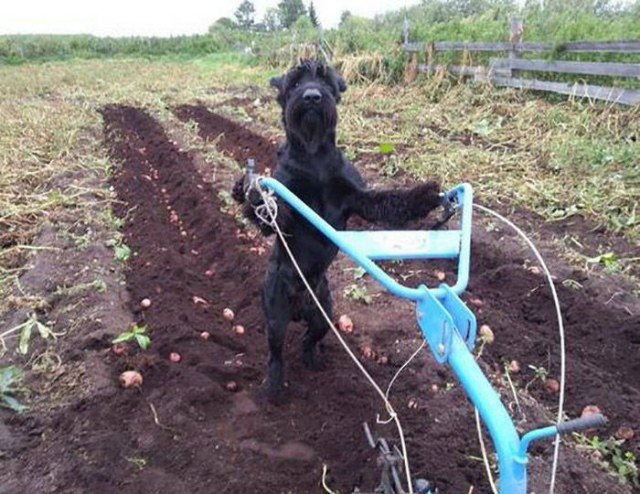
[[271, 59, 347, 154]]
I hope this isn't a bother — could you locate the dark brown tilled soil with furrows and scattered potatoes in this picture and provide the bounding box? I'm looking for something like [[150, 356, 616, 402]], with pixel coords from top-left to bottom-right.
[[0, 71, 640, 494]]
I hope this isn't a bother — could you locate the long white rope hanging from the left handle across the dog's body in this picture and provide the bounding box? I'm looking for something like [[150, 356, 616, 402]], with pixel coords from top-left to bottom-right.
[[256, 184, 413, 494]]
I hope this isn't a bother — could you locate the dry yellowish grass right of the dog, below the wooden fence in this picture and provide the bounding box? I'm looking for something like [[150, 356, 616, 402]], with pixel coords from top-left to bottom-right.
[[341, 80, 640, 247]]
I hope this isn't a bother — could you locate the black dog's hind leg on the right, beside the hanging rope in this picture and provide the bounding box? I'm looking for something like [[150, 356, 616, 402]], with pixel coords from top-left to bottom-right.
[[302, 275, 333, 370]]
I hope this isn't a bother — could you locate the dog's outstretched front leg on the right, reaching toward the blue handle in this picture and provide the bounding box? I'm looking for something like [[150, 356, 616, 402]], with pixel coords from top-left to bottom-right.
[[350, 181, 442, 225]]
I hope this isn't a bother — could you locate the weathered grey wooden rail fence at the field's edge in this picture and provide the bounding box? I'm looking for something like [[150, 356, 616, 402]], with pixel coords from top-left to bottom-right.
[[403, 19, 640, 105]]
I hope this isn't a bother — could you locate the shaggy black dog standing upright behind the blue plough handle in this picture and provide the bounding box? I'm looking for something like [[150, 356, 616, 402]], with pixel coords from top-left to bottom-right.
[[233, 60, 443, 398]]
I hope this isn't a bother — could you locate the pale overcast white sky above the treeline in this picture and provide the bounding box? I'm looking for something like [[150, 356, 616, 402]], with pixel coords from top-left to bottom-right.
[[0, 0, 419, 36]]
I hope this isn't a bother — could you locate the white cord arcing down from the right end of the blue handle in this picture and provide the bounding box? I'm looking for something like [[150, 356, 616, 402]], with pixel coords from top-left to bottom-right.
[[473, 204, 566, 494]]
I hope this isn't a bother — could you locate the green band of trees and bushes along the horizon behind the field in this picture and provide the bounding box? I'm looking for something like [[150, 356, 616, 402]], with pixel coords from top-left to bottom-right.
[[5, 0, 640, 65]]
